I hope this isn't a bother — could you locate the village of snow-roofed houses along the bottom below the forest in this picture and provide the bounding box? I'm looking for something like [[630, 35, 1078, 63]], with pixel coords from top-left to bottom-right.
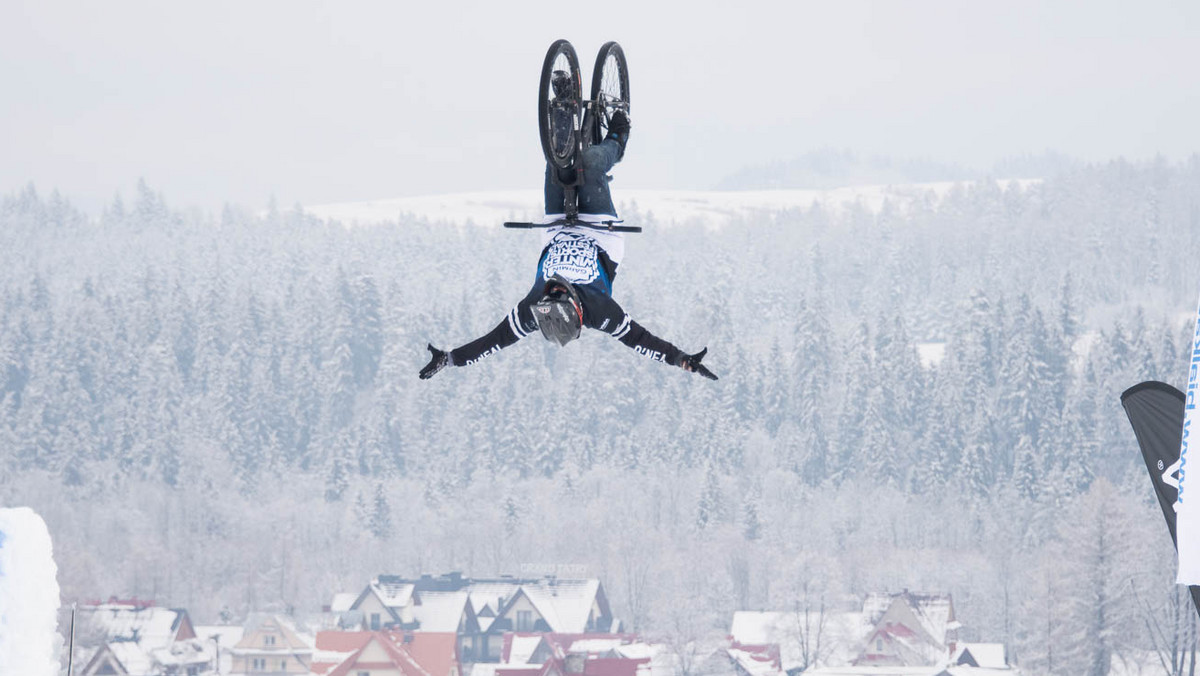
[[65, 573, 1003, 676]]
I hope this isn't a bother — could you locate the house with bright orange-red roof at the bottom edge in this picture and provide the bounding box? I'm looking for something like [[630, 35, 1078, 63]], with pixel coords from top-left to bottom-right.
[[311, 630, 460, 676]]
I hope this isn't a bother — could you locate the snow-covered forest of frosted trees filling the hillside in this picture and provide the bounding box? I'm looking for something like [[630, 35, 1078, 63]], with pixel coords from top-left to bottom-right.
[[0, 157, 1200, 674]]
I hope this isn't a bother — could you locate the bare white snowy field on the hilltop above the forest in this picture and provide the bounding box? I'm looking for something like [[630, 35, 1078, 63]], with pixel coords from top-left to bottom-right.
[[305, 179, 1039, 226]]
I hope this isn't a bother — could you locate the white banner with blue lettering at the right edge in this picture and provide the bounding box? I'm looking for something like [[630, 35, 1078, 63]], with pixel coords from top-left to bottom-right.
[[1175, 294, 1200, 585]]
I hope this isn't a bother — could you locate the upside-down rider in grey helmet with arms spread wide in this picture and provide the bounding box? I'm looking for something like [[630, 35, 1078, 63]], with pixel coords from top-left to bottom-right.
[[420, 105, 716, 381]]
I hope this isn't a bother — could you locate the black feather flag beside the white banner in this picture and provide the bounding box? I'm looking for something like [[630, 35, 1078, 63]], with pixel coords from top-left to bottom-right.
[[1121, 381, 1200, 612]]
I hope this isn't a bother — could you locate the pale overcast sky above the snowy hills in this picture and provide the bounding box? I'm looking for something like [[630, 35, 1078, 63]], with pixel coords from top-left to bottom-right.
[[0, 0, 1200, 210]]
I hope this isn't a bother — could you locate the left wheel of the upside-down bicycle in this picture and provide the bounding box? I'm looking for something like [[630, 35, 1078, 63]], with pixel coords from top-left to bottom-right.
[[538, 40, 583, 169]]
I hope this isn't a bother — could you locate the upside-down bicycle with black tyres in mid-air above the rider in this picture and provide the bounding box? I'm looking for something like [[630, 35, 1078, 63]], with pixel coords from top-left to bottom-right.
[[504, 40, 642, 233]]
